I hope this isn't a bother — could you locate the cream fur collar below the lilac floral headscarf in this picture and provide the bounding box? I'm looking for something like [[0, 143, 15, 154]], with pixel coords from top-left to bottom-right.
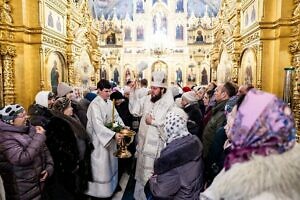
[[201, 144, 300, 200]]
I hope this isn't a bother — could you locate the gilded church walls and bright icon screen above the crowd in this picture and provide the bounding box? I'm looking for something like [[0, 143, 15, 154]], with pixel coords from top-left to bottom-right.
[[0, 0, 300, 138]]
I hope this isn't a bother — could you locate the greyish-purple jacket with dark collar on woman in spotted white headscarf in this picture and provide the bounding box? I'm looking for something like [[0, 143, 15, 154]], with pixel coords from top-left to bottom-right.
[[149, 135, 203, 200]]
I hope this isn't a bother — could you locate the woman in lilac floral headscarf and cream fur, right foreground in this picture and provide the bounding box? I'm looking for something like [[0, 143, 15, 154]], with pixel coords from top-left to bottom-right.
[[201, 89, 300, 200]]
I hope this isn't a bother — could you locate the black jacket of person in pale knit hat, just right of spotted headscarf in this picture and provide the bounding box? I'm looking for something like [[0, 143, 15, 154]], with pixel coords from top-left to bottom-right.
[[183, 103, 203, 140]]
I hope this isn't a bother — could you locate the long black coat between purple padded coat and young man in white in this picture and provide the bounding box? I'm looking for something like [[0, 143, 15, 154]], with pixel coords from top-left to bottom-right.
[[46, 111, 92, 200]]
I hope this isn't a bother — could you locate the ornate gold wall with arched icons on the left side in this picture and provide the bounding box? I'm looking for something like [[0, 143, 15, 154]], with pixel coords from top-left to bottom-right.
[[0, 0, 100, 108]]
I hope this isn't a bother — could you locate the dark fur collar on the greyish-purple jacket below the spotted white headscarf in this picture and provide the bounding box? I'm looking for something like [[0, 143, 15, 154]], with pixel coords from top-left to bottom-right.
[[154, 135, 203, 174]]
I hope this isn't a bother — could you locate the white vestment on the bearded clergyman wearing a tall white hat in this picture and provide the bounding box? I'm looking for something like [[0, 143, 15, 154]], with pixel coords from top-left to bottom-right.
[[129, 90, 174, 200]]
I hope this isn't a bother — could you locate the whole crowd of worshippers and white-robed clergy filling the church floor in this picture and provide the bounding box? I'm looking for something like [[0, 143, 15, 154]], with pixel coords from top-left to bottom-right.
[[0, 71, 300, 200]]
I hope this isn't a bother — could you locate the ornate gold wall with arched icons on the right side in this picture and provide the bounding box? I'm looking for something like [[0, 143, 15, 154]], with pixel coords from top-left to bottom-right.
[[211, 0, 300, 138]]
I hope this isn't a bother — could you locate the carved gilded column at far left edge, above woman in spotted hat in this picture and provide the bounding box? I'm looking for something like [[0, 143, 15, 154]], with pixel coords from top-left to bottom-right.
[[0, 45, 16, 105]]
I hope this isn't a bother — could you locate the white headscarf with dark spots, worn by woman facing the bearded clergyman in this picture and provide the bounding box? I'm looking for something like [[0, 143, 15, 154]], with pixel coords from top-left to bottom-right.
[[164, 107, 190, 144]]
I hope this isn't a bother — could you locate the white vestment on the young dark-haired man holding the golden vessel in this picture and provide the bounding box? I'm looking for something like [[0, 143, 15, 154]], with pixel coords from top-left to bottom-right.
[[86, 96, 124, 198]]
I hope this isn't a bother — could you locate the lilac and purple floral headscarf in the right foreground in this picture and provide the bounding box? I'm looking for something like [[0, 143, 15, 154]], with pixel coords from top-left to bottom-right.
[[224, 89, 296, 170]]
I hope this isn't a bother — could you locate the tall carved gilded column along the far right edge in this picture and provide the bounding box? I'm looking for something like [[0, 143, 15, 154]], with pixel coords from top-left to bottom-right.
[[289, 0, 300, 142]]
